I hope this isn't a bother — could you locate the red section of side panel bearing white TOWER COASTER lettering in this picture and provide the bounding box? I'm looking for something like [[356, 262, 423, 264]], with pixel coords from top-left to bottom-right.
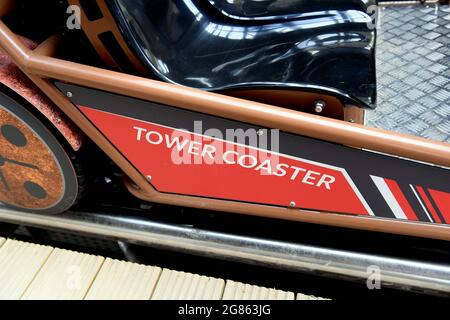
[[80, 106, 372, 215]]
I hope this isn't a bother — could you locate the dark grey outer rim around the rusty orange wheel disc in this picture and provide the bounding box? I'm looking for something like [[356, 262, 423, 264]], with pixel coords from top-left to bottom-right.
[[0, 92, 80, 214]]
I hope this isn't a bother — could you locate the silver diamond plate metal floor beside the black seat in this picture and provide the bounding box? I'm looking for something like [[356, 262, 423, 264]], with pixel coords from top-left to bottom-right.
[[367, 5, 450, 143]]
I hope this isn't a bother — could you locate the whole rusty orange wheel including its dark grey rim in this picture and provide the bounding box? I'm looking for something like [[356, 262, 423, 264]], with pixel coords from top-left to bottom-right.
[[0, 93, 78, 214]]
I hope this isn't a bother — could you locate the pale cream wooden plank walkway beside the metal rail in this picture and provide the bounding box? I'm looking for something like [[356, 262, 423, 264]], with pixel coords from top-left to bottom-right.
[[0, 238, 326, 300]]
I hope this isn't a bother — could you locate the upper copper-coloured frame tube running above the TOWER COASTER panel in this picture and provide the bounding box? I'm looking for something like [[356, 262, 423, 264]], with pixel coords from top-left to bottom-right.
[[0, 22, 450, 167]]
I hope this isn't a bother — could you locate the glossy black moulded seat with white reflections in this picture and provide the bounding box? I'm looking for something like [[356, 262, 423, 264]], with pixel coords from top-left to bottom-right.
[[109, 0, 376, 105]]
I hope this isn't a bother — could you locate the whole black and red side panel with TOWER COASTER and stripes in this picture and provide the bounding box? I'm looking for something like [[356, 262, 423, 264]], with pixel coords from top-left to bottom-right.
[[56, 83, 450, 224]]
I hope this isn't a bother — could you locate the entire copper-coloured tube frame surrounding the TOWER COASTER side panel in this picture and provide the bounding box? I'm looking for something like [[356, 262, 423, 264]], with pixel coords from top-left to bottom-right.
[[0, 15, 450, 240]]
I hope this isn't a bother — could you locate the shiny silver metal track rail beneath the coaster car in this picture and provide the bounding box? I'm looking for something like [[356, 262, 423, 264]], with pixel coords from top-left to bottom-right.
[[0, 209, 450, 293]]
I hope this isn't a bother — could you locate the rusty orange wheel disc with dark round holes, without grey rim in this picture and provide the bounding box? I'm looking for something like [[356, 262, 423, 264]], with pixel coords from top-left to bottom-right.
[[0, 106, 64, 209]]
